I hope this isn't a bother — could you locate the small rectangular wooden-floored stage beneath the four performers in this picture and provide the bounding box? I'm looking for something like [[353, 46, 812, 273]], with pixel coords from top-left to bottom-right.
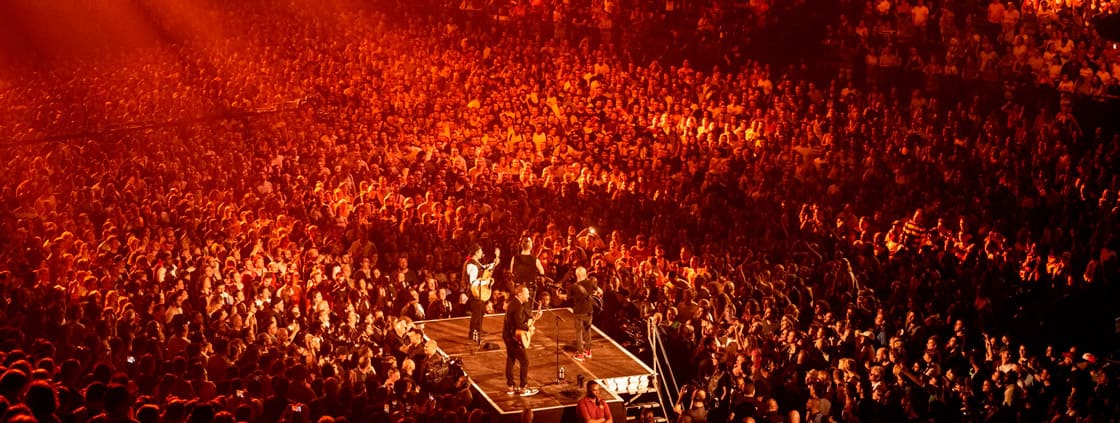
[[422, 309, 653, 422]]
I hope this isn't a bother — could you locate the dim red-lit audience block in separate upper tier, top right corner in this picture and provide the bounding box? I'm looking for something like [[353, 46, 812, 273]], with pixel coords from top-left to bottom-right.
[[827, 0, 1120, 97]]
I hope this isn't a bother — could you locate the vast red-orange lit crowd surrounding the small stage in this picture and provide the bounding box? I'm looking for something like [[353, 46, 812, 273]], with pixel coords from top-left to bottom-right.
[[0, 1, 1120, 423]]
